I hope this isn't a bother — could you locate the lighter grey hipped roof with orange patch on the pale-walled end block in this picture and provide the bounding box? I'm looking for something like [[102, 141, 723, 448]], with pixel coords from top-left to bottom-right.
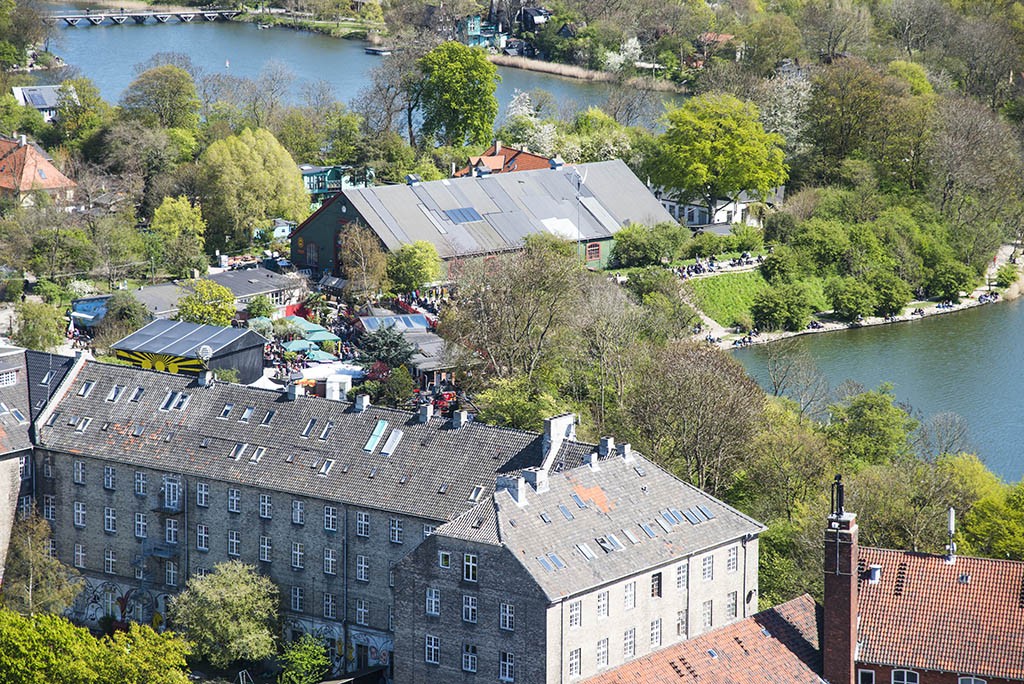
[[436, 454, 765, 600]]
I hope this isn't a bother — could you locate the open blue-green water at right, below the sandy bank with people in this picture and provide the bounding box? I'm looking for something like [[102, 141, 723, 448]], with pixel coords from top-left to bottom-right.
[[733, 299, 1024, 481]]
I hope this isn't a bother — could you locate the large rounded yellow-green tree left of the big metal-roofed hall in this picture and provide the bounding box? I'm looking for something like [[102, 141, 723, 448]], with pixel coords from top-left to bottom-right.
[[198, 128, 309, 250]]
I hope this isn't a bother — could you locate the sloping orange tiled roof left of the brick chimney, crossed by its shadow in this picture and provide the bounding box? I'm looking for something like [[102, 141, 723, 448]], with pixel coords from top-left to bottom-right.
[[585, 594, 822, 684]]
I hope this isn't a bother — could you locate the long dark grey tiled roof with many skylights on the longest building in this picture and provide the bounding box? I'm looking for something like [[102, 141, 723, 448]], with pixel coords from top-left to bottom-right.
[[37, 361, 593, 521]]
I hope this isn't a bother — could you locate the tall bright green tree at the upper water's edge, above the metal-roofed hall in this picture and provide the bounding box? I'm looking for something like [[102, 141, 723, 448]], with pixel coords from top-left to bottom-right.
[[419, 41, 501, 145]]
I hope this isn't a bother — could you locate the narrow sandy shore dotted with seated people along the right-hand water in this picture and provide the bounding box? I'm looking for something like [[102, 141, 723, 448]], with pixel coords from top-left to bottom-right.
[[708, 245, 1024, 350]]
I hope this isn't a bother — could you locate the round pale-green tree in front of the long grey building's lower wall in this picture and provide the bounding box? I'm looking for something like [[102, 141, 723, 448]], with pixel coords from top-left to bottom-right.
[[169, 561, 280, 668]]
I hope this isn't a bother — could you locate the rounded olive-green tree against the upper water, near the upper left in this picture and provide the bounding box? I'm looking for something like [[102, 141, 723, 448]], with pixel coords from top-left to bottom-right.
[[121, 65, 199, 129]]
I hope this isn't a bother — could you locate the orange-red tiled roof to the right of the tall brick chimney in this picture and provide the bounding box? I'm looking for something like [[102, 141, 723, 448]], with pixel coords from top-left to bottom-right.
[[857, 547, 1024, 679]]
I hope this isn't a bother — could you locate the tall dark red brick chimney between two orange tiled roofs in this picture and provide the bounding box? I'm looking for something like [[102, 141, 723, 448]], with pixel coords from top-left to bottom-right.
[[821, 475, 858, 684]]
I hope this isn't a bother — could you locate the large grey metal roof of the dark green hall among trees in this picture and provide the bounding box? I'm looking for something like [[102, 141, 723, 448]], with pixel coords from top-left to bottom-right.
[[338, 160, 674, 258]]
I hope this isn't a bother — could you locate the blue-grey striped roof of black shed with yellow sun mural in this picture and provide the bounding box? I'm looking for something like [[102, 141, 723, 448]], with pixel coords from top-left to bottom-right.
[[112, 318, 266, 358]]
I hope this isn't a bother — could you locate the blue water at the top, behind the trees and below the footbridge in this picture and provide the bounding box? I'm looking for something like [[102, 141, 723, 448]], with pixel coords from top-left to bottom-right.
[[46, 4, 647, 113]]
